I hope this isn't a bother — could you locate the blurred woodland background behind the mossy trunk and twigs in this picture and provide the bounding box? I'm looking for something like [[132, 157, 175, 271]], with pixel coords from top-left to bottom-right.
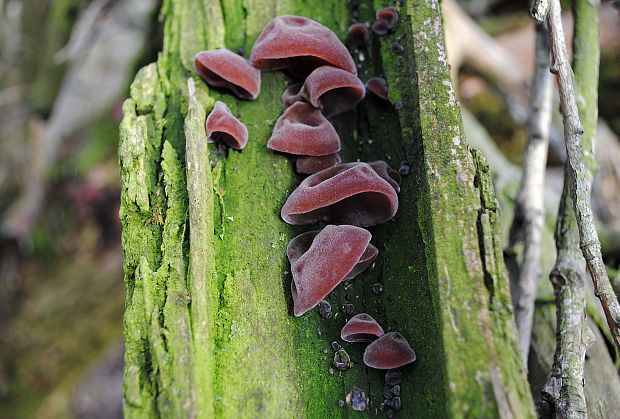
[[0, 0, 620, 418]]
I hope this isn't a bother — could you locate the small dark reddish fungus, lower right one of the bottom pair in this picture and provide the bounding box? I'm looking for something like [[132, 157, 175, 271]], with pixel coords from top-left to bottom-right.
[[363, 332, 415, 370]]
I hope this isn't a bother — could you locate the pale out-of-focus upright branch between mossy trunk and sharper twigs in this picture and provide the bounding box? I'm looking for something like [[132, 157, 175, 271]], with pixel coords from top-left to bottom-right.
[[509, 24, 553, 362]]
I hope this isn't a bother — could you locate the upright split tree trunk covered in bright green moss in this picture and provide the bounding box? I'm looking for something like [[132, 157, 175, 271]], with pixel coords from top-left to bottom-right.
[[119, 0, 534, 418]]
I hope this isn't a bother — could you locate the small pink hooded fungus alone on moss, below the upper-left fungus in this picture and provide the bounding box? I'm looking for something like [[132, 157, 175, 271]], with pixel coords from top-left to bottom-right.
[[206, 101, 248, 150]]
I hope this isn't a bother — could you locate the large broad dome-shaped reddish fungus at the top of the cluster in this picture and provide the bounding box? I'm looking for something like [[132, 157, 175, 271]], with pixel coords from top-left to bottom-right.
[[250, 16, 357, 77]]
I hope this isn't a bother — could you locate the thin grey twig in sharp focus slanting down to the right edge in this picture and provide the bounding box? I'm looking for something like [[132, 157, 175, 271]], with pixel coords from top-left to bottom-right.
[[547, 0, 620, 350]]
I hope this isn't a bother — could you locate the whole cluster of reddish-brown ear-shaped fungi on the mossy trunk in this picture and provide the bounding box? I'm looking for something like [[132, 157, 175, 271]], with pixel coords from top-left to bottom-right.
[[194, 7, 415, 416]]
